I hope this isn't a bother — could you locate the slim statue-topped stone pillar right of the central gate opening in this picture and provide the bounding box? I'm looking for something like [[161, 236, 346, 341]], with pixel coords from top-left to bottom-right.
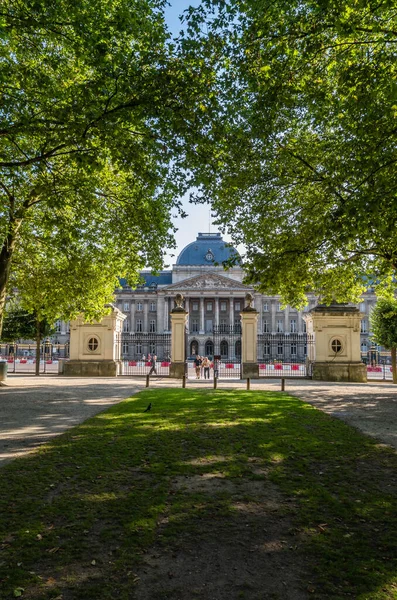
[[240, 293, 259, 379]]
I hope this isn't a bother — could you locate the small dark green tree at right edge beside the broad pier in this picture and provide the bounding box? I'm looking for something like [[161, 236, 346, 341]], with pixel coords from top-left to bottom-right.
[[370, 297, 397, 383]]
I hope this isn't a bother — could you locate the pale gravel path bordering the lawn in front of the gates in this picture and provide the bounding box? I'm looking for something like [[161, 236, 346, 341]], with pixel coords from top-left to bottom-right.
[[0, 375, 397, 466]]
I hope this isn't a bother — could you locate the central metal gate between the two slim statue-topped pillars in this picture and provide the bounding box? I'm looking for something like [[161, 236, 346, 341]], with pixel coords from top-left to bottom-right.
[[187, 324, 241, 379]]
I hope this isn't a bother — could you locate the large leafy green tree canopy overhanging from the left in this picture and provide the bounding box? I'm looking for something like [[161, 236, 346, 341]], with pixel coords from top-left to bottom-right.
[[0, 0, 215, 330]]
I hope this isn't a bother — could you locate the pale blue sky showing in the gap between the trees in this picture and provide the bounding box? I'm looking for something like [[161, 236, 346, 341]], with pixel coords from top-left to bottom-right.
[[160, 0, 235, 264]]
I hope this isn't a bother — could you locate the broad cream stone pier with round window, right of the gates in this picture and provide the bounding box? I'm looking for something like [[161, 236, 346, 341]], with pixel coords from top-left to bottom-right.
[[305, 303, 367, 383]]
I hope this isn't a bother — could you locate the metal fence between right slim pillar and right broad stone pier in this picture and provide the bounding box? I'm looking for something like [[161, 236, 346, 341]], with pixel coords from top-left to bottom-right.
[[258, 333, 314, 378]]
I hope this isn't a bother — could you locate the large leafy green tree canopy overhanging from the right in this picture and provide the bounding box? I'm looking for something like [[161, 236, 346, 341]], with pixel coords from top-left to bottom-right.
[[183, 0, 397, 305]]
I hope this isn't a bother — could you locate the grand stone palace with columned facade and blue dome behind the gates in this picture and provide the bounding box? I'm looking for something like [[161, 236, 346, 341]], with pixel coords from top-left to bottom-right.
[[60, 233, 376, 359]]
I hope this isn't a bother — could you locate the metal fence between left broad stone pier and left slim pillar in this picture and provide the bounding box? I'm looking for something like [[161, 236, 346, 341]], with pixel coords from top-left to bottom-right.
[[120, 333, 171, 377]]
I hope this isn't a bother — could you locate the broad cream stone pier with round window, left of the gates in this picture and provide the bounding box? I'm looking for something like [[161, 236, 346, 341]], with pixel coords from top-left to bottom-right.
[[63, 304, 126, 377]]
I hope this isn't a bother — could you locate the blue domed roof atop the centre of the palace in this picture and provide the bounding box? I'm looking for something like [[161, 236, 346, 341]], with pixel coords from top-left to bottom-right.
[[176, 233, 239, 266]]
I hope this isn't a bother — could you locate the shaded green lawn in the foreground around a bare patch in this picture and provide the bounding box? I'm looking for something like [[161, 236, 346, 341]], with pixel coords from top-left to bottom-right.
[[0, 389, 397, 600]]
